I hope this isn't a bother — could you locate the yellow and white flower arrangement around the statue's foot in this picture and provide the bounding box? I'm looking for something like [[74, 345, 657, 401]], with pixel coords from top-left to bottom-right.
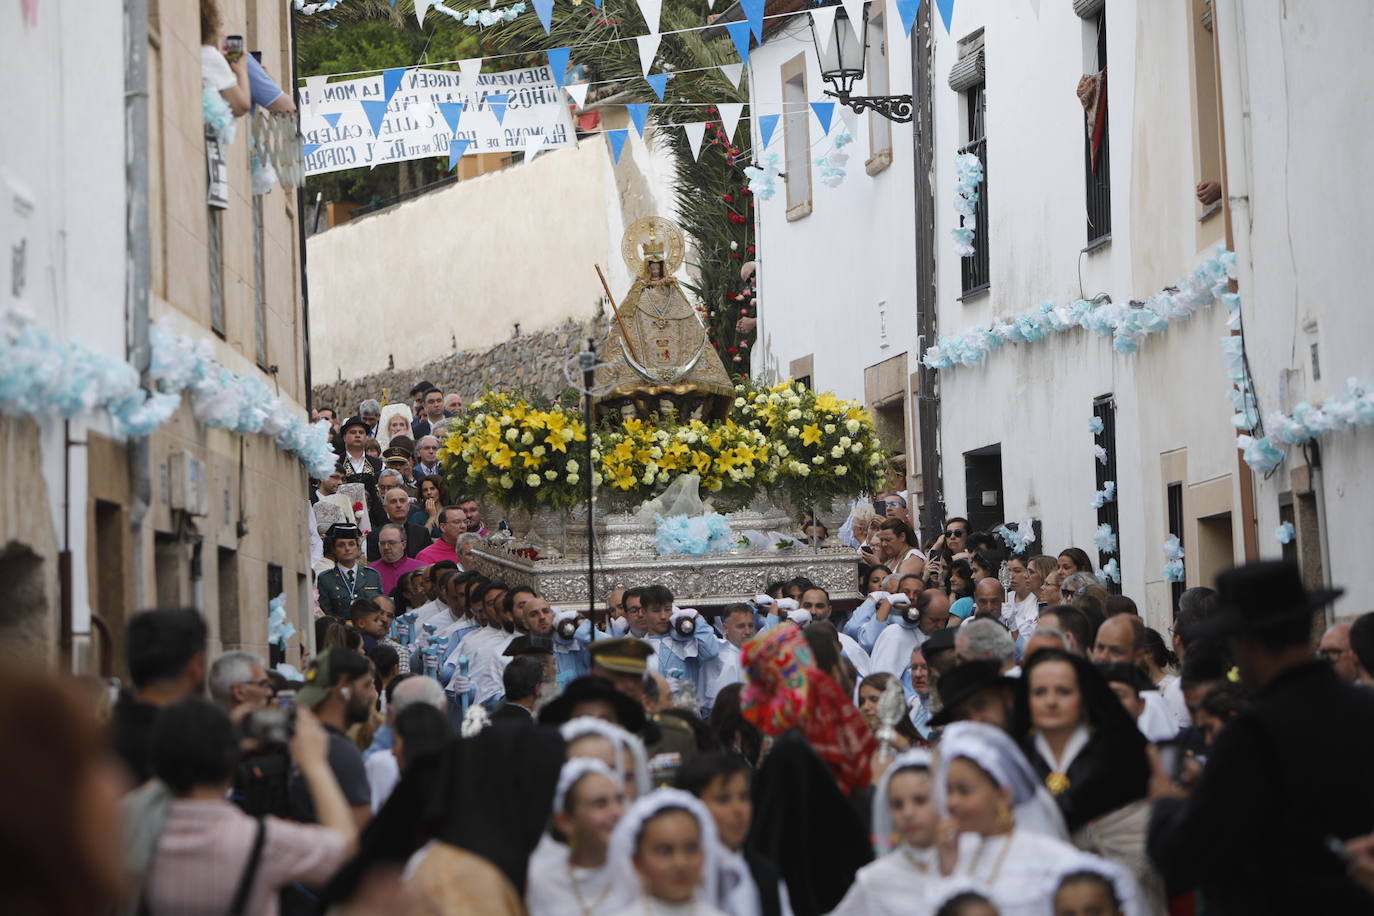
[[440, 382, 886, 512]]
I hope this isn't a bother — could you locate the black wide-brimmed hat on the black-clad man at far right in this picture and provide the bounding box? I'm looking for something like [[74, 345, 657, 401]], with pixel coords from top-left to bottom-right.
[[1201, 560, 1345, 636]]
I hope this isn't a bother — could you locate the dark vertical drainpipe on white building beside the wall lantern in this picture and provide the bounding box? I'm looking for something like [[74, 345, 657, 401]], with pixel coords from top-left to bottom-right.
[[911, 3, 945, 538]]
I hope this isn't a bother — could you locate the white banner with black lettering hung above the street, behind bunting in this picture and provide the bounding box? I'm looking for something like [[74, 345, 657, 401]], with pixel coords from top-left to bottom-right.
[[301, 66, 576, 174]]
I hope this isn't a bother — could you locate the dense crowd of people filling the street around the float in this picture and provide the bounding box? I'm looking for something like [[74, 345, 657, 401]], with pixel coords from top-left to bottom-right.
[[8, 386, 1374, 916]]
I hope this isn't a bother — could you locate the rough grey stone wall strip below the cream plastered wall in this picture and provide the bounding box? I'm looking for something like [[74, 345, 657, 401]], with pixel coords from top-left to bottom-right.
[[315, 319, 607, 419]]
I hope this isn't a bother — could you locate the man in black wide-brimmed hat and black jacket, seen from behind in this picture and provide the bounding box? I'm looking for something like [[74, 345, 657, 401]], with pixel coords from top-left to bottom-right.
[[1149, 562, 1374, 916]]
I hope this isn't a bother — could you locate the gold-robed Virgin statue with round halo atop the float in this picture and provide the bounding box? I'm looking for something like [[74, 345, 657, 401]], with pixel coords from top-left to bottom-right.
[[598, 217, 735, 420]]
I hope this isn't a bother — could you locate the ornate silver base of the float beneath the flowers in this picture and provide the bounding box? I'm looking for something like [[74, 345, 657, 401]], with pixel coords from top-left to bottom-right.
[[473, 504, 856, 611]]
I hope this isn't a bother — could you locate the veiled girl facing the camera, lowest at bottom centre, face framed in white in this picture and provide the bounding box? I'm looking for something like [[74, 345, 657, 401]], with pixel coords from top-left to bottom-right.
[[610, 788, 724, 916]]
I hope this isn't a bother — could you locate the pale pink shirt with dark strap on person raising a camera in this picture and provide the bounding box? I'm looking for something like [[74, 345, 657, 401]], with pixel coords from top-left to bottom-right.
[[144, 799, 345, 916]]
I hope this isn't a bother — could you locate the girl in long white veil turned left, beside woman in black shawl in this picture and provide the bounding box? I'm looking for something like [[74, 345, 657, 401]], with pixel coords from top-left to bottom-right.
[[937, 722, 1139, 916]]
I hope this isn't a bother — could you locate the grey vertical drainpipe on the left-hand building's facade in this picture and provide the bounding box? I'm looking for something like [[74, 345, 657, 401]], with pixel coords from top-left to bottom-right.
[[124, 0, 153, 610]]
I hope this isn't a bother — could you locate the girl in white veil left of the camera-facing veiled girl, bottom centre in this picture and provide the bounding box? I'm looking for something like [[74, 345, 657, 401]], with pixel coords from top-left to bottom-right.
[[525, 757, 635, 916]]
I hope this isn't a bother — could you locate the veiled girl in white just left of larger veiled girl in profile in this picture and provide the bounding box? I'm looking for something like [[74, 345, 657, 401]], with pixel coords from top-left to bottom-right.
[[833, 750, 940, 916]]
